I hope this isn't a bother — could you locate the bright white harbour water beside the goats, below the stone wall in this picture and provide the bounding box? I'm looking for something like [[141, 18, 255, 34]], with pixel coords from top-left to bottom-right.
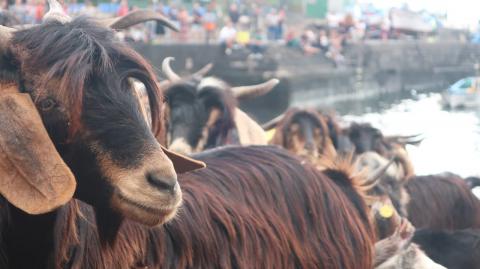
[[339, 93, 480, 177]]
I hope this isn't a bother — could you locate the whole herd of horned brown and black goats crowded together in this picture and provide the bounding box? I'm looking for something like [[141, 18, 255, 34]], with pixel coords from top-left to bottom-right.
[[0, 0, 480, 269]]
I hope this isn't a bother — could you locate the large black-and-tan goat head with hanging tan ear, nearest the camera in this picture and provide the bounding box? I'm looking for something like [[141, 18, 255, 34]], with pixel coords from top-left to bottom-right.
[[0, 0, 204, 268]]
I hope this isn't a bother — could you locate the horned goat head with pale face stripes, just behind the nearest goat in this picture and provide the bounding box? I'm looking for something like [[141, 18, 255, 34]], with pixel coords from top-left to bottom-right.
[[160, 58, 279, 154]]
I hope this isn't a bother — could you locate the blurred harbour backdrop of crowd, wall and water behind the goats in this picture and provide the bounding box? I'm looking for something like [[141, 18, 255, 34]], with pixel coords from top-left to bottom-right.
[[0, 0, 480, 180]]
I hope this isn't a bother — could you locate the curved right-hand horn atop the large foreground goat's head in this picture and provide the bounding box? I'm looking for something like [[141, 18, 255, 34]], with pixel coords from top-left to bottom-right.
[[100, 10, 178, 32]]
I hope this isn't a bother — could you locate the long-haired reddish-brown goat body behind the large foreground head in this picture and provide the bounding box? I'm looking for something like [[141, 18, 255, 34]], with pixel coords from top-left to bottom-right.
[[0, 146, 374, 269]]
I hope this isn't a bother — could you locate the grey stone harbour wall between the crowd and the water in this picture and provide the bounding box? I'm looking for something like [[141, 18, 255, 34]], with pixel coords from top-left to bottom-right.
[[135, 41, 480, 121]]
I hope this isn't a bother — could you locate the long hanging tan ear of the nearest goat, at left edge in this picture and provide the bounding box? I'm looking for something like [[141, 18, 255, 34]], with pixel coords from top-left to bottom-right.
[[0, 85, 76, 214]]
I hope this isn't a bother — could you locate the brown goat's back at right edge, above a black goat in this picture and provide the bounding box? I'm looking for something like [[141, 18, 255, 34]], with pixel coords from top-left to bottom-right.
[[405, 174, 480, 230]]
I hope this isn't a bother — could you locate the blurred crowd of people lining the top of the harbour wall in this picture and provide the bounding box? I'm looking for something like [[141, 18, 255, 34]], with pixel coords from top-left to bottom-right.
[[0, 0, 480, 66]]
